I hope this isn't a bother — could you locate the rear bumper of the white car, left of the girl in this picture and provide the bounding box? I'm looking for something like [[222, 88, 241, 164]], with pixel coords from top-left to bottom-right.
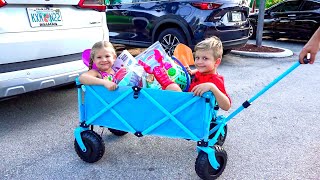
[[0, 60, 88, 98]]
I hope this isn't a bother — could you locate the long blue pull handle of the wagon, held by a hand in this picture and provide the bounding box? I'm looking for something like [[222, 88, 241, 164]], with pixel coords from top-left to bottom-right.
[[224, 58, 310, 123]]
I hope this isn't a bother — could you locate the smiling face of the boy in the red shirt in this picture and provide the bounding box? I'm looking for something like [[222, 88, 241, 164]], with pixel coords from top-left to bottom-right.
[[194, 50, 218, 74]]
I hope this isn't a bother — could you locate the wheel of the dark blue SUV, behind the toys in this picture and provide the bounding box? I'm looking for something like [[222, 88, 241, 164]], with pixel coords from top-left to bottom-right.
[[157, 28, 187, 56]]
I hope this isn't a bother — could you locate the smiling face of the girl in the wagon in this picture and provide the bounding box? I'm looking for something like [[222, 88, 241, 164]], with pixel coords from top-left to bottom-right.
[[93, 47, 116, 72]]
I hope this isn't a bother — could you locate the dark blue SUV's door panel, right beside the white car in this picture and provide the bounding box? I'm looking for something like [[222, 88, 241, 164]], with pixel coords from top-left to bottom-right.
[[106, 0, 135, 45]]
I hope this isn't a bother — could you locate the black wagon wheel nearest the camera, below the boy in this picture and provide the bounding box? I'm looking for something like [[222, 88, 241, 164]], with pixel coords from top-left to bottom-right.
[[195, 145, 228, 180]]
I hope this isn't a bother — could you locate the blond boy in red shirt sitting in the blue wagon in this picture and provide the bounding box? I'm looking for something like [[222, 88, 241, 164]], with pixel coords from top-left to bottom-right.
[[189, 36, 231, 111]]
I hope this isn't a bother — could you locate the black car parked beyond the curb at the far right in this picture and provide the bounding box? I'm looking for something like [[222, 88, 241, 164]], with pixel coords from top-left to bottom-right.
[[249, 0, 320, 39]]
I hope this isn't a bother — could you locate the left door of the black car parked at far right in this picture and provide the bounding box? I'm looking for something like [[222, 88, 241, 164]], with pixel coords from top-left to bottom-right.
[[271, 1, 301, 38]]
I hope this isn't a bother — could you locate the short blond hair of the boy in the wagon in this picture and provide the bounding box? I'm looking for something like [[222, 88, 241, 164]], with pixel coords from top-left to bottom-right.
[[194, 36, 223, 59]]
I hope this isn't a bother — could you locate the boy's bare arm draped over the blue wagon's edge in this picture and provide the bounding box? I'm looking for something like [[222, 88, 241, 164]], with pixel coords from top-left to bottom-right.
[[191, 82, 231, 111]]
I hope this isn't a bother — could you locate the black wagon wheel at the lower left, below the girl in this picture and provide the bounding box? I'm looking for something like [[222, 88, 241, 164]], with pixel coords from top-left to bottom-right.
[[74, 130, 105, 163]]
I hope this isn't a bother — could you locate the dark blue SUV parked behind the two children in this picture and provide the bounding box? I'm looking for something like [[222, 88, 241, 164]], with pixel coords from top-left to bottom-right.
[[106, 0, 249, 55]]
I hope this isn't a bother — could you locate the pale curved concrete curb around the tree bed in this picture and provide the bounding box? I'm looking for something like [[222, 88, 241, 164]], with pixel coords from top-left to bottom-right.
[[231, 46, 293, 58]]
